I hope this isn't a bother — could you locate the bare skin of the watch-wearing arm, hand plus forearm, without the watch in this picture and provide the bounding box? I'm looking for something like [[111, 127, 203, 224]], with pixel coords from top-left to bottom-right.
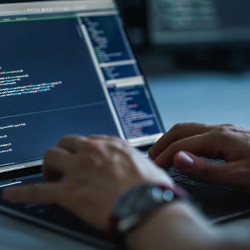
[[3, 131, 250, 250]]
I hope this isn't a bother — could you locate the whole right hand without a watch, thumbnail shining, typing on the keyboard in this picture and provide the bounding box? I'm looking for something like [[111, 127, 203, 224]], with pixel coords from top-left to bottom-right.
[[149, 123, 250, 193]]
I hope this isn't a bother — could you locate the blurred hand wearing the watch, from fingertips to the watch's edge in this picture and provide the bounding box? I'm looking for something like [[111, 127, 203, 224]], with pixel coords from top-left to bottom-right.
[[3, 136, 172, 231]]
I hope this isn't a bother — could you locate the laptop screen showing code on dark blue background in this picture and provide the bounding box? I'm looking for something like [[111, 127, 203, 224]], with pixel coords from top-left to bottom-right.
[[0, 0, 163, 172]]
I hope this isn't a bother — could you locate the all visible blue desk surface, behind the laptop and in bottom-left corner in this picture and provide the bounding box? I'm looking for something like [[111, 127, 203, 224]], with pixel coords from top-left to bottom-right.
[[0, 73, 250, 250]]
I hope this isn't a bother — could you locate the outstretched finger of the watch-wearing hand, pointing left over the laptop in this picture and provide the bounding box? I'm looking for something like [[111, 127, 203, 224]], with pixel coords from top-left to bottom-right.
[[3, 183, 61, 204]]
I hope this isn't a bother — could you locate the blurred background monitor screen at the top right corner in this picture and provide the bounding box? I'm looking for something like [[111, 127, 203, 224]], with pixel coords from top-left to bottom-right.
[[148, 0, 250, 45]]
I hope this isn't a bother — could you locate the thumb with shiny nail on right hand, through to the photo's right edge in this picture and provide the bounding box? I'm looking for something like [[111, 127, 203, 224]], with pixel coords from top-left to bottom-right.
[[174, 151, 250, 192]]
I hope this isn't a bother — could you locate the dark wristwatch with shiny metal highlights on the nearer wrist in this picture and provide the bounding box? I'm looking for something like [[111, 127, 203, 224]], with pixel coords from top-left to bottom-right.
[[110, 184, 189, 239]]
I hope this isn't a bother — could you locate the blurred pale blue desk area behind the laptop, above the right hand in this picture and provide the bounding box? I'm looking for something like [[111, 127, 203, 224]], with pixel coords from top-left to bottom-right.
[[149, 72, 250, 130]]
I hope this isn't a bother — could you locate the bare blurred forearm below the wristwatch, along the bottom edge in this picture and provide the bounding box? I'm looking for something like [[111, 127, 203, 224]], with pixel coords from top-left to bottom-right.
[[127, 202, 250, 250]]
